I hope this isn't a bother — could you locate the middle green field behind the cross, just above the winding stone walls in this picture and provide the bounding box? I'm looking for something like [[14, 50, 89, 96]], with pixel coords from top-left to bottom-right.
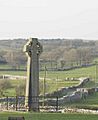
[[2, 80, 79, 96]]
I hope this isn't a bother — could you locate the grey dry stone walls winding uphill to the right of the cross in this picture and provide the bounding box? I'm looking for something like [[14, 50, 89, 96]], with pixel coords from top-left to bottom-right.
[[46, 78, 90, 106]]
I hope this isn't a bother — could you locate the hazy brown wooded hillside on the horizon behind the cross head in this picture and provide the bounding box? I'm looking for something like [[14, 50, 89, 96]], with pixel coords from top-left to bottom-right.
[[0, 39, 98, 67]]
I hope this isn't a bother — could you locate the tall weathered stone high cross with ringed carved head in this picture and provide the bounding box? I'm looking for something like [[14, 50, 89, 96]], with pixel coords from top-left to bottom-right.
[[24, 38, 42, 111]]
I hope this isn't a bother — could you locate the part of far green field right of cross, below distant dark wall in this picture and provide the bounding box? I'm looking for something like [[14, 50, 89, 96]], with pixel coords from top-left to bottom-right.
[[40, 66, 96, 79]]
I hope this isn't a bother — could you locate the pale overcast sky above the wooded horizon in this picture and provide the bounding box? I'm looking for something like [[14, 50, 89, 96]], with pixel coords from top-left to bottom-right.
[[0, 0, 98, 40]]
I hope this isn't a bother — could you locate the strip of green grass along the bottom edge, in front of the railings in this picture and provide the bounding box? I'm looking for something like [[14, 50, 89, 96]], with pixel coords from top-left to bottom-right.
[[0, 112, 98, 120]]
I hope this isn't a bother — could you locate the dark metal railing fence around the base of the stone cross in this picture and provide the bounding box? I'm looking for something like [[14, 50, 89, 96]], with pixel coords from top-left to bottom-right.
[[0, 96, 63, 112]]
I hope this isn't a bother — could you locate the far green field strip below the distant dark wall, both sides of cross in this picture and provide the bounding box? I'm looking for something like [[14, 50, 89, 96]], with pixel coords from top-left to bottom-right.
[[0, 66, 97, 80]]
